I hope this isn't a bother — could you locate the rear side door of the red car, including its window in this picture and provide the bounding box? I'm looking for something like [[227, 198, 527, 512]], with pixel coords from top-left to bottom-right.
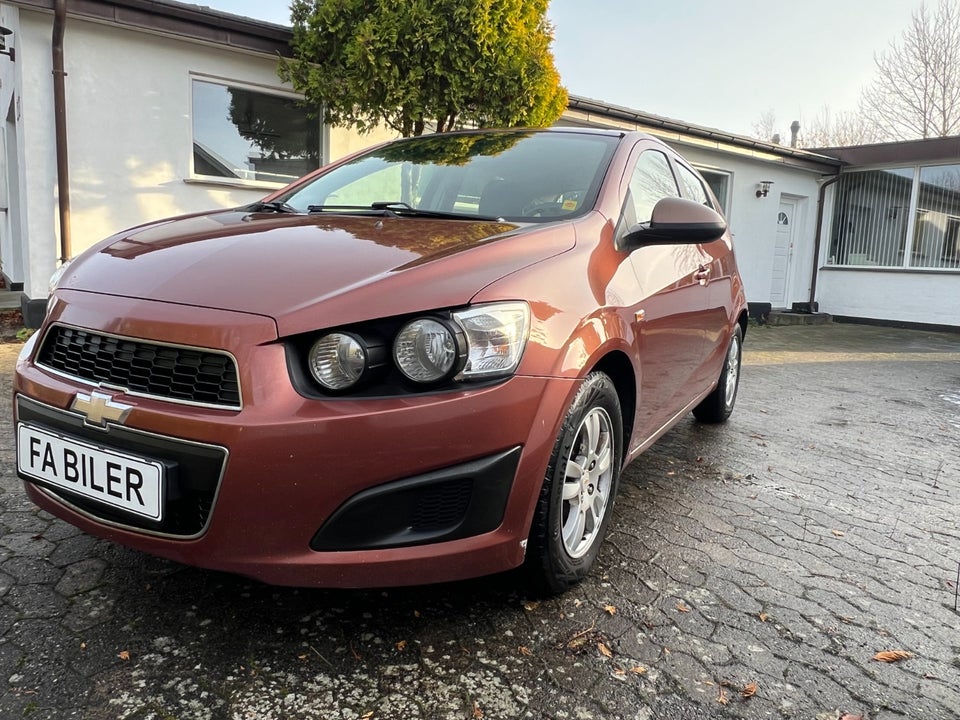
[[674, 158, 734, 387]]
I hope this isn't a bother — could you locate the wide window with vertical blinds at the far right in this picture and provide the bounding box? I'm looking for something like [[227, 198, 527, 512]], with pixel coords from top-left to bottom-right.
[[827, 165, 960, 270]]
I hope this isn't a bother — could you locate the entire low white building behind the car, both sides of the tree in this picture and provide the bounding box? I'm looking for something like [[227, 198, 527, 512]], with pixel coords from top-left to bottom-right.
[[0, 0, 960, 327]]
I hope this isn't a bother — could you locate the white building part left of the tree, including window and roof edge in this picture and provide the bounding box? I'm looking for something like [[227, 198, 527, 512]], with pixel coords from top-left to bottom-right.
[[0, 0, 394, 322]]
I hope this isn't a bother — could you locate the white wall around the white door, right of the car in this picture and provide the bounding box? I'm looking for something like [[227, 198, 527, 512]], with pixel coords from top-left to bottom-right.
[[670, 142, 821, 308]]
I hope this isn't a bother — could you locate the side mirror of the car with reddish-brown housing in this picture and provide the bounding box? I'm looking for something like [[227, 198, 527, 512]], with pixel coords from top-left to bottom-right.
[[620, 198, 727, 250]]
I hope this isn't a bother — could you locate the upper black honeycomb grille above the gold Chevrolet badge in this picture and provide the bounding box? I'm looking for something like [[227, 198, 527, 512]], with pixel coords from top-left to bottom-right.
[[38, 325, 240, 407]]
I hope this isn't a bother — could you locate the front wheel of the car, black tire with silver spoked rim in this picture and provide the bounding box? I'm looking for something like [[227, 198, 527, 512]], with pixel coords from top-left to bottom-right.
[[525, 372, 623, 595]]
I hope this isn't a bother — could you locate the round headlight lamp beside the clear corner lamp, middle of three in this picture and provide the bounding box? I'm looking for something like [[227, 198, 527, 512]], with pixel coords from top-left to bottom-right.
[[393, 317, 465, 383]]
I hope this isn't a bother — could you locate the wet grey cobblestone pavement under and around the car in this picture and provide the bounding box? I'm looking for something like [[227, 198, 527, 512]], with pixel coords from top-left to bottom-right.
[[0, 325, 960, 720]]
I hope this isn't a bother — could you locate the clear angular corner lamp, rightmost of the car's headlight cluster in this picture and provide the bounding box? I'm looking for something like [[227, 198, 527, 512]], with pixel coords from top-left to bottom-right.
[[453, 302, 530, 379]]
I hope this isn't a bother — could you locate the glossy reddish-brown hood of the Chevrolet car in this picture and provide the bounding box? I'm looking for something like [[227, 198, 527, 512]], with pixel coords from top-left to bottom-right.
[[59, 210, 574, 335]]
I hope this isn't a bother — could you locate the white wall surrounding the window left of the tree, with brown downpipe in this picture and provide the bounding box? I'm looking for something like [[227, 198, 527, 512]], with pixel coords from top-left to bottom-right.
[[14, 9, 387, 298]]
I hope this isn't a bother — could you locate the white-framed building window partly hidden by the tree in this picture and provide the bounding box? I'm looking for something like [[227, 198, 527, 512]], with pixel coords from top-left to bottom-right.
[[193, 79, 322, 187]]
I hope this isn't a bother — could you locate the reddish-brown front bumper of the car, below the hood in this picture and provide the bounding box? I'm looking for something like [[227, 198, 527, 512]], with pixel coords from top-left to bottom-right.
[[15, 294, 574, 587]]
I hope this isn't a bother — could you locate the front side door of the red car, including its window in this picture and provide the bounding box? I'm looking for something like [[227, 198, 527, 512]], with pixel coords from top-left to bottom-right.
[[618, 141, 709, 442]]
